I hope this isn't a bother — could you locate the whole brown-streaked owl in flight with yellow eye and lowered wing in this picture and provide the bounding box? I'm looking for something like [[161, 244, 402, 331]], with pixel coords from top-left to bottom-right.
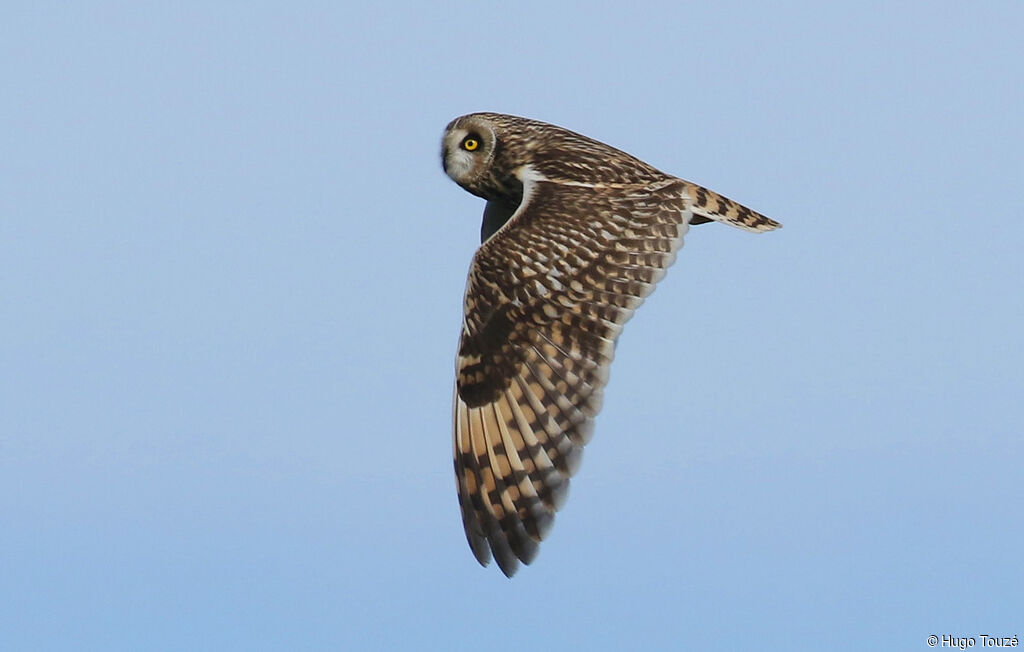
[[441, 113, 781, 577]]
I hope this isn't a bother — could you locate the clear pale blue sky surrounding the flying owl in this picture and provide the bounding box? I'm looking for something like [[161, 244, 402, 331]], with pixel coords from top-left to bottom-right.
[[0, 2, 1024, 651]]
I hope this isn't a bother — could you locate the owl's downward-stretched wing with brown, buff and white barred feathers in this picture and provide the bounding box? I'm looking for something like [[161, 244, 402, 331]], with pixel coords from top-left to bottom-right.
[[455, 172, 694, 576]]
